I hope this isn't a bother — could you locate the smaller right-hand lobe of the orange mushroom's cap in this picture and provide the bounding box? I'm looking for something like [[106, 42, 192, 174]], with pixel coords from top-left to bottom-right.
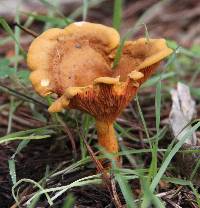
[[114, 38, 172, 81]]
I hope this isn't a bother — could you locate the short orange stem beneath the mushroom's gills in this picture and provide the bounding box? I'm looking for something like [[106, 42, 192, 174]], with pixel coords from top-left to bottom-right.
[[96, 121, 119, 160]]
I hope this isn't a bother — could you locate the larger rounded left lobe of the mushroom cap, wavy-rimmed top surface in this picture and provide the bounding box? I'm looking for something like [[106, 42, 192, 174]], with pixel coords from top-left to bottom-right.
[[27, 22, 119, 96]]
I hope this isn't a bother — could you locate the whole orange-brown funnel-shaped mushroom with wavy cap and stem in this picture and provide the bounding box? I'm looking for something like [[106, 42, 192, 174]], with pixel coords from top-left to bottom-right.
[[27, 22, 172, 167]]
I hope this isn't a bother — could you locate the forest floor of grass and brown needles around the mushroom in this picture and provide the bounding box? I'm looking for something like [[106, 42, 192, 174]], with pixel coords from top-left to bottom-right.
[[0, 0, 200, 208]]
